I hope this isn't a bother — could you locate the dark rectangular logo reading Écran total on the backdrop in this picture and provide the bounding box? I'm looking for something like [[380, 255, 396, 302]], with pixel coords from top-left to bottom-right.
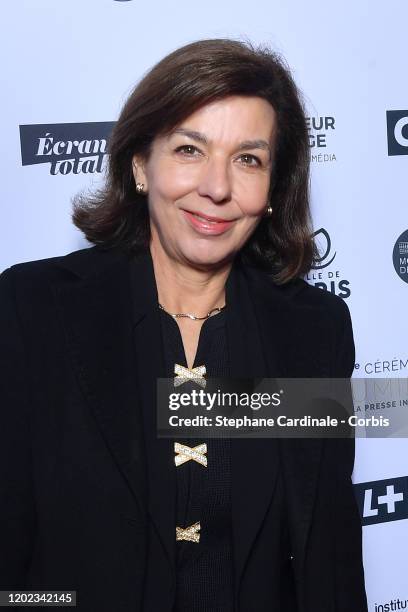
[[20, 121, 115, 175]]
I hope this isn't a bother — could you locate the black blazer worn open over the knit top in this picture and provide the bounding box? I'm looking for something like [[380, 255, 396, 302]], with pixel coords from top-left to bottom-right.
[[0, 247, 367, 612]]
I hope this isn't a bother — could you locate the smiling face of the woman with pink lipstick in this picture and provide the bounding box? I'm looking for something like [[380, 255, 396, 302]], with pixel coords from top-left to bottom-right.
[[133, 96, 276, 269]]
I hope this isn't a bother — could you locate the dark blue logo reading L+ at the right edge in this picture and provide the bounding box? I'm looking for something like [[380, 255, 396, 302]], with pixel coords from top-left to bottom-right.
[[354, 476, 408, 525]]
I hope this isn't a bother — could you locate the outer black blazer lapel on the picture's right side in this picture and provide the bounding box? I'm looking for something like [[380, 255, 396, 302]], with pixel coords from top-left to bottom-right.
[[248, 270, 330, 580]]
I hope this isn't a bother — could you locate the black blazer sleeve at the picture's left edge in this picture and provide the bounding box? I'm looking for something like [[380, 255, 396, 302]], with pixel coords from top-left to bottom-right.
[[0, 267, 35, 590]]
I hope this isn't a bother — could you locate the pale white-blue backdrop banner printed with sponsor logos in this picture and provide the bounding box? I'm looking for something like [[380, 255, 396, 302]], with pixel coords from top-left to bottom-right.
[[0, 0, 408, 612]]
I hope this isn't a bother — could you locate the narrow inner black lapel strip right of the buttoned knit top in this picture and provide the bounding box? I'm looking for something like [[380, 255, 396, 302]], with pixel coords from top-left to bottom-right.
[[226, 261, 278, 597]]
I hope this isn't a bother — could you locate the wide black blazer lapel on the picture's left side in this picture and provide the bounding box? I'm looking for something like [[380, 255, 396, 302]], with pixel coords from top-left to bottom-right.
[[54, 247, 147, 513]]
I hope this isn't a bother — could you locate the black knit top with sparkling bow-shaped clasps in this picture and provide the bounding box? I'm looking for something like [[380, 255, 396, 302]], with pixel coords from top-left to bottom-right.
[[160, 310, 234, 612]]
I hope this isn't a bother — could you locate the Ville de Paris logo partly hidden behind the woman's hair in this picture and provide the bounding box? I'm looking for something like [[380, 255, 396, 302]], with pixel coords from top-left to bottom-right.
[[305, 227, 351, 298]]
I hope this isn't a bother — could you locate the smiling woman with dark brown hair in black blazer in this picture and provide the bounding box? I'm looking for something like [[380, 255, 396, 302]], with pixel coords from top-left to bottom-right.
[[0, 39, 367, 612]]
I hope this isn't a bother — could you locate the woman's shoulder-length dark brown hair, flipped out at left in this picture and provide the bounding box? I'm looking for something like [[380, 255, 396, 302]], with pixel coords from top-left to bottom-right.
[[73, 39, 315, 283]]
